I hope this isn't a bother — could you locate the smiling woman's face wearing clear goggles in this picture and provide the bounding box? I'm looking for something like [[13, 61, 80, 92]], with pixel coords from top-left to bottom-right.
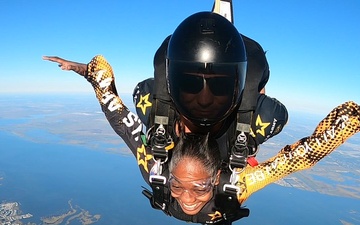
[[169, 157, 218, 215]]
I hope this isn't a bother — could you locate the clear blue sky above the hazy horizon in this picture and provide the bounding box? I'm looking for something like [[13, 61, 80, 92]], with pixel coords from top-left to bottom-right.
[[0, 0, 360, 113]]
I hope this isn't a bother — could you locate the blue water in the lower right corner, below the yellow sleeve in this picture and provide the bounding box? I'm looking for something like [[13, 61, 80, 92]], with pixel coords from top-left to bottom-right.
[[245, 184, 360, 225]]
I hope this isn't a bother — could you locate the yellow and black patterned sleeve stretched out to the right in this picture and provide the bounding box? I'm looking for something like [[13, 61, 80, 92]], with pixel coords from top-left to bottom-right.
[[237, 101, 360, 203]]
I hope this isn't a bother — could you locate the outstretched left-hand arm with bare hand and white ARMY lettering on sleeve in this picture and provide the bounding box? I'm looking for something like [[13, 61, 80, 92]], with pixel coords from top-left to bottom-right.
[[43, 56, 150, 167]]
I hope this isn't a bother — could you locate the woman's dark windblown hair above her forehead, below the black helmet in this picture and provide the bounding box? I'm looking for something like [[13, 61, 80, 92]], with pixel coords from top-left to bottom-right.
[[169, 133, 221, 177]]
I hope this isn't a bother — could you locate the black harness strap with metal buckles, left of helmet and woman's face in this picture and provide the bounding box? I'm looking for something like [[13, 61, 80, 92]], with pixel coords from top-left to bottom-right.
[[143, 36, 176, 215]]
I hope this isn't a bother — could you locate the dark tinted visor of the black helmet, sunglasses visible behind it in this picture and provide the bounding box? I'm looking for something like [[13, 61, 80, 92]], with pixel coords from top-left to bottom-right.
[[168, 61, 246, 125]]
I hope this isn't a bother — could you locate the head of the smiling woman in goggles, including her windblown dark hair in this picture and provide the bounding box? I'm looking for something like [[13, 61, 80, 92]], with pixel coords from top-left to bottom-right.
[[169, 134, 221, 215]]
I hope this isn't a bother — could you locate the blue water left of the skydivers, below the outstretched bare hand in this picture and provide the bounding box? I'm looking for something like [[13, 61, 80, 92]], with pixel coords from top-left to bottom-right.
[[0, 132, 177, 224]]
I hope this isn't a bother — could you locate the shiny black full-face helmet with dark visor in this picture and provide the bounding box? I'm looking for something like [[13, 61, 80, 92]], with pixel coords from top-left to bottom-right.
[[166, 12, 246, 127]]
